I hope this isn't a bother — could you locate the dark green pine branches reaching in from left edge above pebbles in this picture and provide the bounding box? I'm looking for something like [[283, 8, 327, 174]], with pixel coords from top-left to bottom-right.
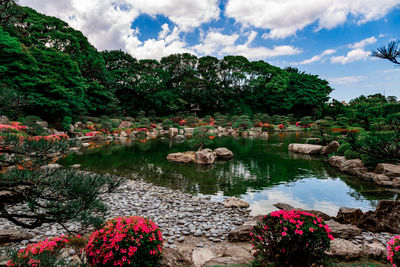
[[0, 132, 119, 229]]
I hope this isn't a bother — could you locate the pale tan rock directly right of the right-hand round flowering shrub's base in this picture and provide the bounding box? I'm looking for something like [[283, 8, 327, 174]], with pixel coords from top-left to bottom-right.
[[327, 238, 363, 261]]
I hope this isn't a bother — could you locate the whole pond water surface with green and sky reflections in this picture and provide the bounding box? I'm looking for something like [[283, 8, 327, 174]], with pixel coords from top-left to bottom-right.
[[61, 133, 396, 218]]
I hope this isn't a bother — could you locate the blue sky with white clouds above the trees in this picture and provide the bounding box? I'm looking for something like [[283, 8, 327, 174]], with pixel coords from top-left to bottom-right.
[[18, 0, 400, 101]]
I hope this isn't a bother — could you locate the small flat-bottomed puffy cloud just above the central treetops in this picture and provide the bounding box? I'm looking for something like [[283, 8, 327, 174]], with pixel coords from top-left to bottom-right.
[[193, 30, 301, 60]]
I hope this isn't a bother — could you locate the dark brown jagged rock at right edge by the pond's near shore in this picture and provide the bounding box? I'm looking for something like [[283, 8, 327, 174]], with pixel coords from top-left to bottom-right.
[[357, 200, 400, 234]]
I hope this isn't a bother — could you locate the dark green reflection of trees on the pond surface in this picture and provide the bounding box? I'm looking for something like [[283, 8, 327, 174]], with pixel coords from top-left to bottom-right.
[[59, 133, 393, 203]]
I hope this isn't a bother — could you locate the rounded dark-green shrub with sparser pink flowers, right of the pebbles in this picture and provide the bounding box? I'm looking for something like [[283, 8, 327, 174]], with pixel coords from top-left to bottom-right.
[[250, 210, 333, 266]]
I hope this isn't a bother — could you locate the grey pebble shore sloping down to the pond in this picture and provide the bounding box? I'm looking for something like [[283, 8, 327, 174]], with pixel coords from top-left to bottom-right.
[[0, 180, 250, 250]]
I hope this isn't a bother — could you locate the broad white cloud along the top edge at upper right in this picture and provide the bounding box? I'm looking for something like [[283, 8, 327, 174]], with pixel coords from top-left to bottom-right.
[[225, 0, 400, 39]]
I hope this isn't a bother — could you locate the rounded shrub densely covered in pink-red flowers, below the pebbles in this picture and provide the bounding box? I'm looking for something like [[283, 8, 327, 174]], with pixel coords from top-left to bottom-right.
[[86, 216, 163, 267]]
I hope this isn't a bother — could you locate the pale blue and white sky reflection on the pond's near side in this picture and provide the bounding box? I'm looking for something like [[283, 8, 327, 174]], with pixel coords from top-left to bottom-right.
[[213, 178, 378, 216]]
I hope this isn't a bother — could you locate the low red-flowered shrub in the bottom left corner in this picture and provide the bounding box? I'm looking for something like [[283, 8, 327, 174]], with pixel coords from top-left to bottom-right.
[[7, 235, 82, 267]]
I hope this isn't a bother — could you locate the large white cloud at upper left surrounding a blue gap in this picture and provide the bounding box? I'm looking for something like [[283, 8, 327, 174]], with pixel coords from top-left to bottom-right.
[[19, 0, 220, 58]]
